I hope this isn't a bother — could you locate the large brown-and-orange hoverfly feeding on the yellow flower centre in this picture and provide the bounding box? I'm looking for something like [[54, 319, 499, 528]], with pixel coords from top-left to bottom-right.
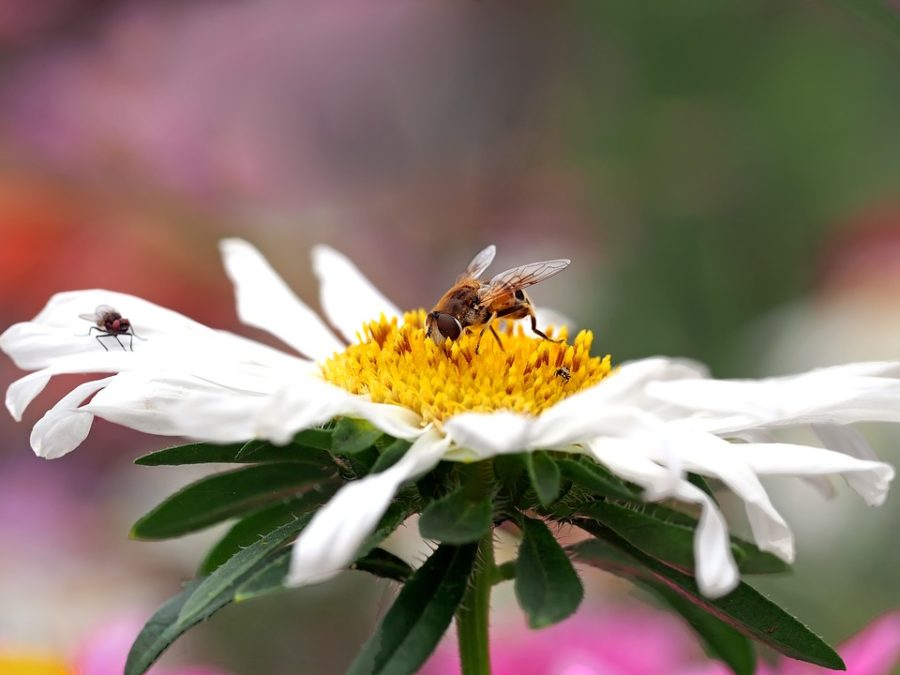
[[425, 244, 571, 354]]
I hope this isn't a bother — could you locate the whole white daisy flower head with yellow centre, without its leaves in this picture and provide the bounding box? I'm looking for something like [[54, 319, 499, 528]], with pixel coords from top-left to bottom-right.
[[0, 239, 900, 597]]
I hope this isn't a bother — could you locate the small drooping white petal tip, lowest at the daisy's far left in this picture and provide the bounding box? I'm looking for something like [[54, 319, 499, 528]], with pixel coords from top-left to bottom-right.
[[31, 377, 112, 459]]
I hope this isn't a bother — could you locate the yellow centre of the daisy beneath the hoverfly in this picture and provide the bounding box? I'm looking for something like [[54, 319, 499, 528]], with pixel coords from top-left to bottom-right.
[[322, 310, 611, 422]]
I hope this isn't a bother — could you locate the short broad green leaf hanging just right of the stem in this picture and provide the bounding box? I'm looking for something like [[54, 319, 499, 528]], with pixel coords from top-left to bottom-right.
[[516, 517, 584, 628]]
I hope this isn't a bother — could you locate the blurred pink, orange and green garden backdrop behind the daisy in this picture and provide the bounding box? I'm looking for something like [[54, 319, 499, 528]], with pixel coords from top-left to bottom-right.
[[0, 0, 900, 675]]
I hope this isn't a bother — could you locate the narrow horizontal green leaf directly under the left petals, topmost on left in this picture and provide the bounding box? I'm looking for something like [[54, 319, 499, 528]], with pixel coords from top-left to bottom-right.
[[134, 440, 334, 467]]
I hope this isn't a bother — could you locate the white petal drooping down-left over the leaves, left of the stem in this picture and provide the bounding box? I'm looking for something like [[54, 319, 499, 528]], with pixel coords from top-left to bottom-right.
[[286, 430, 449, 586]]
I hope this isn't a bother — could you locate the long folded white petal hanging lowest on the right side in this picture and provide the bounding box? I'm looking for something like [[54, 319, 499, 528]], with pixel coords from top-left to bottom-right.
[[588, 440, 740, 598]]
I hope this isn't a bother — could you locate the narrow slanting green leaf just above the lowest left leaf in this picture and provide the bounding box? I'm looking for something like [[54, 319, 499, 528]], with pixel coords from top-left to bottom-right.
[[178, 514, 312, 624]]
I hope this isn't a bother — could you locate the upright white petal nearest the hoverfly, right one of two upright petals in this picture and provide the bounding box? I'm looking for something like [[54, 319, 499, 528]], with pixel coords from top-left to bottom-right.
[[312, 245, 401, 342]]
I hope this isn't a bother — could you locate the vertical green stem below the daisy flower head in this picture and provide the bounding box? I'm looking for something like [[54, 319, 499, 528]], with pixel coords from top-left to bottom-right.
[[456, 532, 494, 675]]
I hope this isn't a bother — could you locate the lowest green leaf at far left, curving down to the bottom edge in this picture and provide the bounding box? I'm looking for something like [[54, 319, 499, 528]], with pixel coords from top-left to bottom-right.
[[125, 580, 231, 675]]
